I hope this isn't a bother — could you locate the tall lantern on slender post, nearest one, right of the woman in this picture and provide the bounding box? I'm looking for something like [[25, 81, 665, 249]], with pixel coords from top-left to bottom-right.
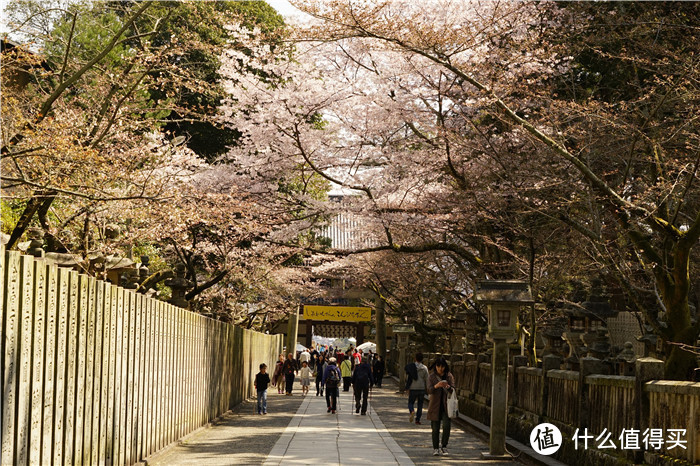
[[474, 280, 534, 460]]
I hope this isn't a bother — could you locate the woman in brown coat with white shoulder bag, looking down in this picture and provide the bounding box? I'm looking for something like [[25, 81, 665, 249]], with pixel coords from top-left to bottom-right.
[[428, 358, 455, 456]]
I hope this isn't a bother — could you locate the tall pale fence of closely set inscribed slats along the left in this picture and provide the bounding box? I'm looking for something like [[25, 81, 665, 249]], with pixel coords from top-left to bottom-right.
[[0, 250, 282, 465]]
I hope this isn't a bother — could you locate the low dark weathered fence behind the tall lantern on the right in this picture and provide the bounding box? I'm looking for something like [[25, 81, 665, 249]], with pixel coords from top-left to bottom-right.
[[427, 353, 700, 464]]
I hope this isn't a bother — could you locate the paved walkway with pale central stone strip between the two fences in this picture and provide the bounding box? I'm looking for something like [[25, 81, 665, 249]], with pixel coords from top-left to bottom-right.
[[146, 379, 514, 466]]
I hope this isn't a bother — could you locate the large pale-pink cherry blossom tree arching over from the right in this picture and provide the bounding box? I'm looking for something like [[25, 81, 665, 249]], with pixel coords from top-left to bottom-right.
[[227, 1, 700, 378]]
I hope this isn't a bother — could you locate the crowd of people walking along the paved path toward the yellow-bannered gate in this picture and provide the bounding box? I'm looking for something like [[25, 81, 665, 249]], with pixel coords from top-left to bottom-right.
[[255, 346, 455, 456]]
